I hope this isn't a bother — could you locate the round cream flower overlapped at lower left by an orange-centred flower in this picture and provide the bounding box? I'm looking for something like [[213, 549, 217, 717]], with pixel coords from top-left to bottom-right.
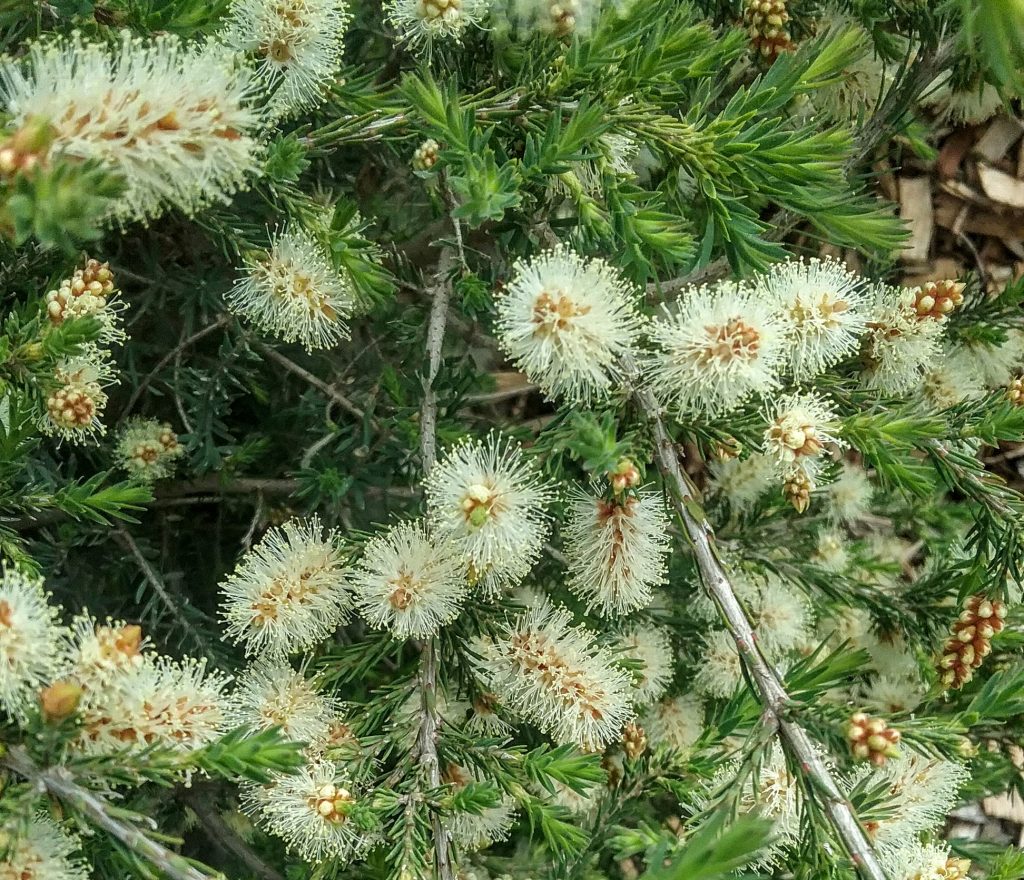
[[756, 259, 867, 382]]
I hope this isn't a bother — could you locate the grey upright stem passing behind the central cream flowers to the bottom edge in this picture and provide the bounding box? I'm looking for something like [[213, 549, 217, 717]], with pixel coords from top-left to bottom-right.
[[417, 248, 455, 880]]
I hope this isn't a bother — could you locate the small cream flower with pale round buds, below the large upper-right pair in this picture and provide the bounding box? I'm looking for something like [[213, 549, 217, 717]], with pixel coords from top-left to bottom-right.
[[764, 392, 845, 483]]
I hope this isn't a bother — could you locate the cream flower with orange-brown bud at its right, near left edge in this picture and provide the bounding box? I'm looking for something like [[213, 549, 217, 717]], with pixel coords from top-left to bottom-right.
[[61, 612, 147, 692]]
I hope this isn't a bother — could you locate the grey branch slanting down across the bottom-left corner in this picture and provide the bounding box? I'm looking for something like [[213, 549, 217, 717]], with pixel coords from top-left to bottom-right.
[[0, 746, 213, 880]]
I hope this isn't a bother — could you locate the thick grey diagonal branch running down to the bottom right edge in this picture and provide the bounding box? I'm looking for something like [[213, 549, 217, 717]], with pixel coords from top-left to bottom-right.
[[624, 358, 888, 880]]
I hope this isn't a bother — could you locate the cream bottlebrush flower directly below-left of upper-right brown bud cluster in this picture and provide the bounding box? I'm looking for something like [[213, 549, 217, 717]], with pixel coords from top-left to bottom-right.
[[862, 287, 944, 394]]
